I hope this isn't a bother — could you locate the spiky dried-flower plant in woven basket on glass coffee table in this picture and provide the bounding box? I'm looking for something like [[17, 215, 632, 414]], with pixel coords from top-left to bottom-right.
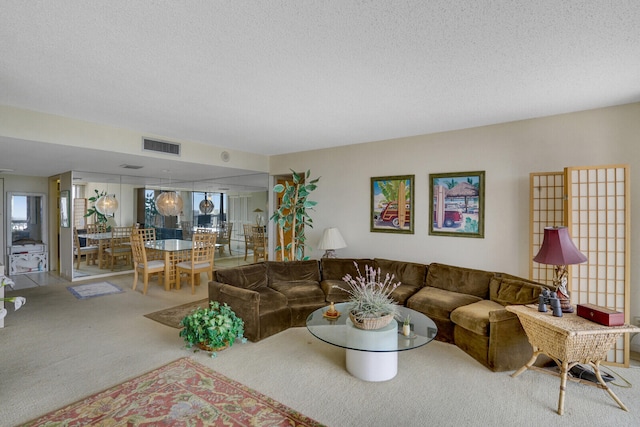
[[340, 263, 400, 329]]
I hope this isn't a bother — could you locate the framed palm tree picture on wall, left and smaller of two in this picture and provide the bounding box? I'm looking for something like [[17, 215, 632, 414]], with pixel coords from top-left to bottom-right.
[[370, 175, 415, 234]]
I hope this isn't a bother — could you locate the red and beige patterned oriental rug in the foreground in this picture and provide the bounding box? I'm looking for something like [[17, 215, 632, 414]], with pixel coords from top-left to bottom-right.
[[25, 357, 322, 427]]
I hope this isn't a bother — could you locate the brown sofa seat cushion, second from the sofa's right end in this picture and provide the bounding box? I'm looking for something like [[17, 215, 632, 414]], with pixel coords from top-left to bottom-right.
[[407, 286, 482, 320]]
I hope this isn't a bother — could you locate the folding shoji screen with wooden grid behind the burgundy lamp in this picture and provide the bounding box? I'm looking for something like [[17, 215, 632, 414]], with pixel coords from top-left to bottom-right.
[[529, 165, 631, 366]]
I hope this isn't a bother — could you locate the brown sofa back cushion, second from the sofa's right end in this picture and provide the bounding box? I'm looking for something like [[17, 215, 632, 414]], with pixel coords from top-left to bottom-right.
[[425, 262, 494, 299]]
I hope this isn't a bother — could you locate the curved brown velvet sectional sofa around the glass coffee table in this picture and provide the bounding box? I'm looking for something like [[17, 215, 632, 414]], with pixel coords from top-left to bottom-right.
[[209, 258, 544, 371]]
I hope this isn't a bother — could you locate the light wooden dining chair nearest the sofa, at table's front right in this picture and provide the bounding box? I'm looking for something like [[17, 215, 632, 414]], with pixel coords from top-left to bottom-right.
[[176, 232, 216, 294]]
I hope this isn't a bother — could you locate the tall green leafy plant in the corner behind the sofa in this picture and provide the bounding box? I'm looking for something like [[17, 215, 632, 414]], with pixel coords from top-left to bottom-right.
[[270, 170, 320, 261]]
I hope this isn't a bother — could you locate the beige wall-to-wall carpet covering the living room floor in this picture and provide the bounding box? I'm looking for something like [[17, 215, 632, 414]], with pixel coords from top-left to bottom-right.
[[0, 276, 640, 427]]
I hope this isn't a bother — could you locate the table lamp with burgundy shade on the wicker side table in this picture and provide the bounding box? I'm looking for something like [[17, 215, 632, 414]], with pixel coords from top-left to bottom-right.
[[533, 226, 587, 313]]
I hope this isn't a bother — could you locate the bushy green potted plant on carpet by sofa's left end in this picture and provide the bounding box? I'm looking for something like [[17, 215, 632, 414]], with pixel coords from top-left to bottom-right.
[[180, 301, 246, 357]]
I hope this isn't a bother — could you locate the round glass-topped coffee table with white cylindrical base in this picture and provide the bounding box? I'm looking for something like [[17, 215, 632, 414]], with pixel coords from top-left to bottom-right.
[[307, 303, 438, 381]]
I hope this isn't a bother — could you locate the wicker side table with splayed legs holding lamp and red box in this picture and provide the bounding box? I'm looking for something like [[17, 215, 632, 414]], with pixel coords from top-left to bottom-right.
[[506, 305, 640, 415]]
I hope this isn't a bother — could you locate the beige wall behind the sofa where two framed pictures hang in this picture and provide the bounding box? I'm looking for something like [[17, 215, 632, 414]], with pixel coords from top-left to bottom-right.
[[270, 103, 640, 322]]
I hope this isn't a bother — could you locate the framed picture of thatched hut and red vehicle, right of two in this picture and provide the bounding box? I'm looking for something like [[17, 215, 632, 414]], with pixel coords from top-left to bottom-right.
[[429, 171, 484, 238]]
